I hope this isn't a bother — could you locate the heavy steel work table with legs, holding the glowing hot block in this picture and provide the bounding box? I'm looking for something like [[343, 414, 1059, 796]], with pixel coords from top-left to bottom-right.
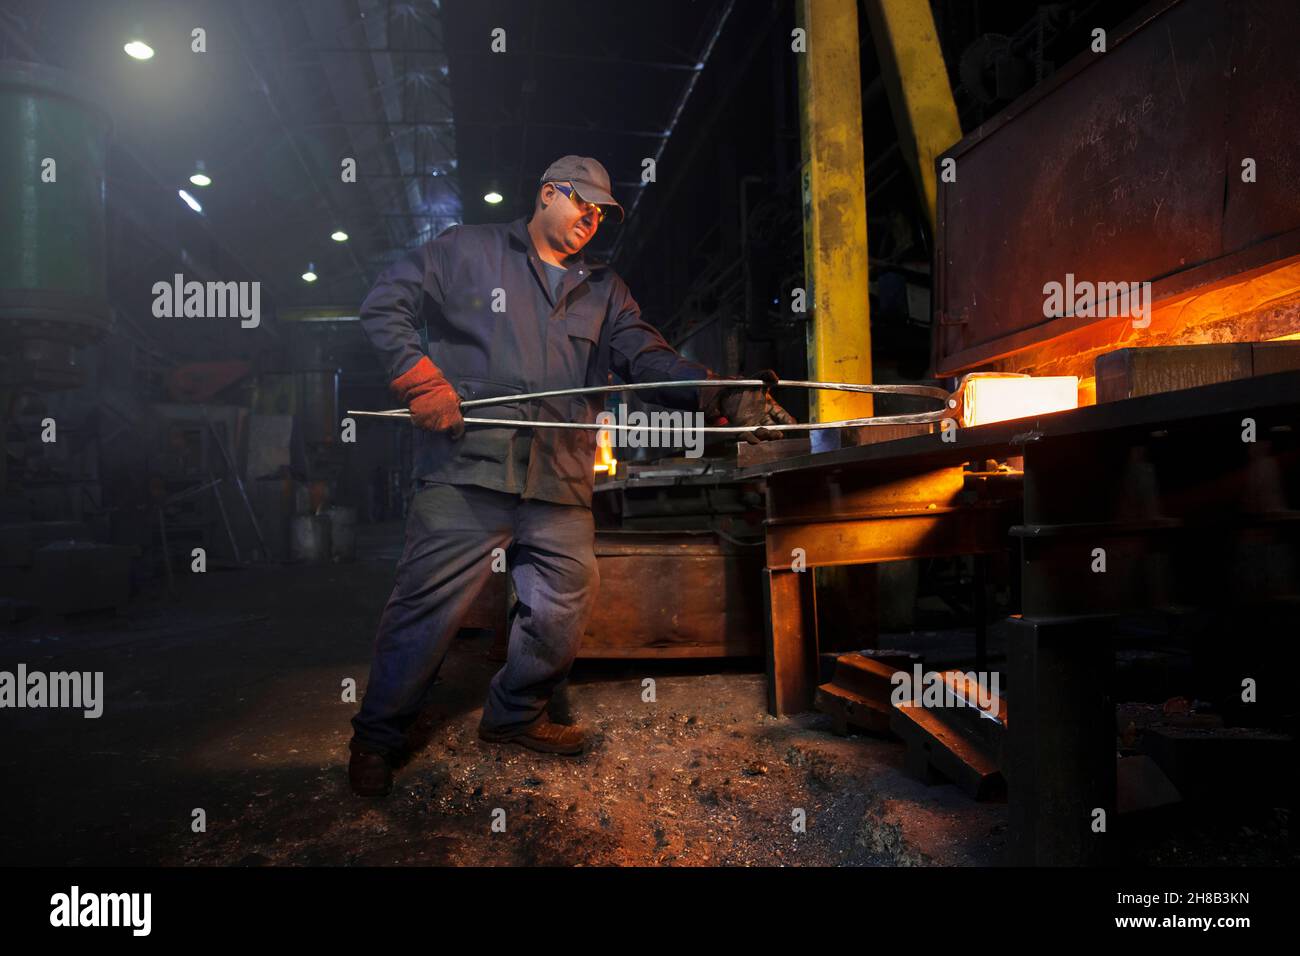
[[736, 372, 1300, 864]]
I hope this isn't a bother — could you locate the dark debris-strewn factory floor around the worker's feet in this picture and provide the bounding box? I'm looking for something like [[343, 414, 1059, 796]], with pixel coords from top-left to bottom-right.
[[0, 525, 1006, 866]]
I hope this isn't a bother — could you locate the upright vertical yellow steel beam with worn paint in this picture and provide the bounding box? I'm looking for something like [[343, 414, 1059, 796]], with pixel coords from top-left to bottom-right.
[[794, 0, 872, 421]]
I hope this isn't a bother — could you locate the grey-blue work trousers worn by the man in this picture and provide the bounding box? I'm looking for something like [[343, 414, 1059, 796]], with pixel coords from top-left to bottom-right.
[[351, 484, 599, 758]]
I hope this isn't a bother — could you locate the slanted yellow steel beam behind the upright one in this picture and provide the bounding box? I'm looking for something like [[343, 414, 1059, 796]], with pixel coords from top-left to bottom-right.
[[863, 0, 962, 229]]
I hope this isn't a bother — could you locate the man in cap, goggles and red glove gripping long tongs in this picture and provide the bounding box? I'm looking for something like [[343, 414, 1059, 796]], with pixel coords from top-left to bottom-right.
[[348, 156, 794, 796]]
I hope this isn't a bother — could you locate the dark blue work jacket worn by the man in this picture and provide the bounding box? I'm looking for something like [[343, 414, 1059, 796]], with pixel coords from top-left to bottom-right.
[[361, 219, 707, 506]]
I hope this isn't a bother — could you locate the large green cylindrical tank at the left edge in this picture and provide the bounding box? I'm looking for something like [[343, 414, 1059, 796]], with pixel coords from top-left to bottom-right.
[[0, 60, 109, 388]]
